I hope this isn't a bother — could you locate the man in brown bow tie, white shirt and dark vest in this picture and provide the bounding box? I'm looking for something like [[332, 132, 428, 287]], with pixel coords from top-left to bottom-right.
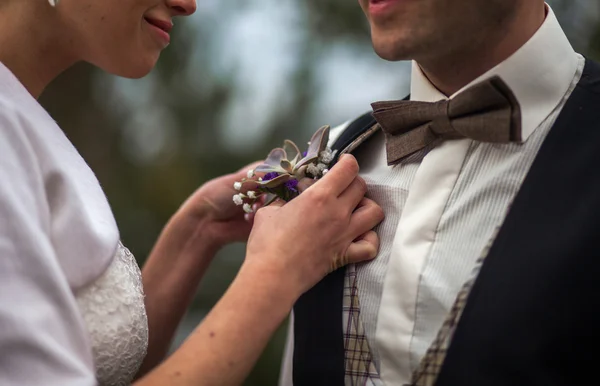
[[281, 0, 600, 386]]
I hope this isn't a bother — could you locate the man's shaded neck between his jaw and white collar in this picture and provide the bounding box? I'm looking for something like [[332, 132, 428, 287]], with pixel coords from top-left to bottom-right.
[[417, 2, 547, 96]]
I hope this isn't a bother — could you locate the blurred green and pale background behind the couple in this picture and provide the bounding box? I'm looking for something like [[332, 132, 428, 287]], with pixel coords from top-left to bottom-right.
[[42, 0, 600, 386]]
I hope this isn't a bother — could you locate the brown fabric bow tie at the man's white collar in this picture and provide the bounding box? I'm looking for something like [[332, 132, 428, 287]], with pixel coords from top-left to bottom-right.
[[371, 76, 521, 165]]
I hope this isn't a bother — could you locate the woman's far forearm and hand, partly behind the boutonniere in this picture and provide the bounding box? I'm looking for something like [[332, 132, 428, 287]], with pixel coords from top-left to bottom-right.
[[138, 164, 257, 377]]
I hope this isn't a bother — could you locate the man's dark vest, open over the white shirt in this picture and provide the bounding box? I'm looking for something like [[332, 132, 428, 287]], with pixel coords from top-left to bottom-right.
[[294, 61, 600, 386]]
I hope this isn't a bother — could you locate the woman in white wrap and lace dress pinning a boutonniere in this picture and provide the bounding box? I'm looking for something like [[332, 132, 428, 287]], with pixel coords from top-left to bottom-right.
[[0, 0, 383, 386]]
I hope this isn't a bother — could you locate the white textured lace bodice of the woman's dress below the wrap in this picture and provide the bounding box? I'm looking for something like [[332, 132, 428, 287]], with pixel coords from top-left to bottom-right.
[[76, 243, 148, 386]]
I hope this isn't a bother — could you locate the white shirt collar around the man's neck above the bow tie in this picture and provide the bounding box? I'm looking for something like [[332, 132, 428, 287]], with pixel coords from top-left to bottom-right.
[[411, 5, 579, 141]]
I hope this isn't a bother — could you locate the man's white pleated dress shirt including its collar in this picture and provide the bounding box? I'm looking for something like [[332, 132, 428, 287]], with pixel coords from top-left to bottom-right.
[[281, 7, 585, 386]]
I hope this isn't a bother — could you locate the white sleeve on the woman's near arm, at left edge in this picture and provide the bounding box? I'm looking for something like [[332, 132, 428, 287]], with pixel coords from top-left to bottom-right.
[[0, 110, 96, 386]]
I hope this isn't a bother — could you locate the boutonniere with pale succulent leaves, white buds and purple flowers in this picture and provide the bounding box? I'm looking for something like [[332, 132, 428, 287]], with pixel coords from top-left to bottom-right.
[[233, 126, 336, 213]]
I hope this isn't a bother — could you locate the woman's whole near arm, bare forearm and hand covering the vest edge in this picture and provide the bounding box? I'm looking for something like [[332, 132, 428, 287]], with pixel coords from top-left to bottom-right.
[[136, 157, 383, 386]]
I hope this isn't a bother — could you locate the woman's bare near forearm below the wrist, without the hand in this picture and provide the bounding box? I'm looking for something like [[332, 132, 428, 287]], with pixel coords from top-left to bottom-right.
[[140, 260, 296, 386]]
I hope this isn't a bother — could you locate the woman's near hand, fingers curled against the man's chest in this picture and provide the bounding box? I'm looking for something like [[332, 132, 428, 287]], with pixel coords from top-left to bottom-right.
[[244, 155, 383, 296]]
